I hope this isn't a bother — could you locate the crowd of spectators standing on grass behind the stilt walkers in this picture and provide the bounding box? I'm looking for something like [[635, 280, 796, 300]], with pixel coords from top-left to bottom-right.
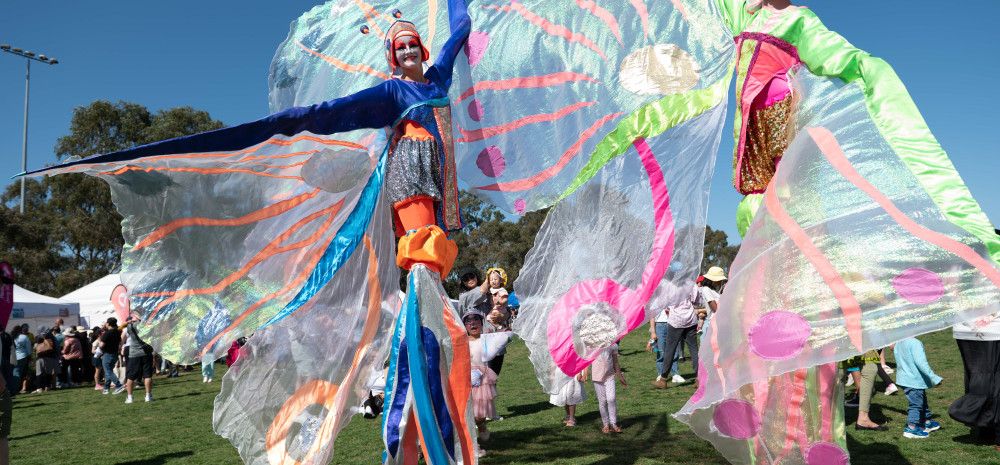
[[0, 267, 1000, 453]]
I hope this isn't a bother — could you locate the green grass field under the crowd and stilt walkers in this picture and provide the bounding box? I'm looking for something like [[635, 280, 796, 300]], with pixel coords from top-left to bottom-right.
[[10, 330, 1000, 465]]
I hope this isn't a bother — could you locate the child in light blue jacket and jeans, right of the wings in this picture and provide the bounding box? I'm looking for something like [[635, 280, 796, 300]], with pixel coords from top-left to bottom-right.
[[893, 337, 941, 439]]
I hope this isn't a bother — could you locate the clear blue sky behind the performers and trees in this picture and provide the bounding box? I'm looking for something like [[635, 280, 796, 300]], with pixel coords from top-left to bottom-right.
[[0, 0, 1000, 240]]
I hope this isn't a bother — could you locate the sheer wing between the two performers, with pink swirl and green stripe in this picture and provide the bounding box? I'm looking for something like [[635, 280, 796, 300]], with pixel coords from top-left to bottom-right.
[[452, 1, 733, 393]]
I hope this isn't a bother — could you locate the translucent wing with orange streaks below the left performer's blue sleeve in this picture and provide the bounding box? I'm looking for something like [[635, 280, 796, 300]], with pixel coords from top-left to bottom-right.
[[26, 122, 384, 363]]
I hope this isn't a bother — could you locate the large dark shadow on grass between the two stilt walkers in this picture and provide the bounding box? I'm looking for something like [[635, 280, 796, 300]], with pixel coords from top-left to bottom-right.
[[483, 412, 723, 465]]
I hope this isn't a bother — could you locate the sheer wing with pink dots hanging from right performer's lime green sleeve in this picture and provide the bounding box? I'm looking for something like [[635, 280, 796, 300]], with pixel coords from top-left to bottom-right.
[[677, 2, 1000, 464]]
